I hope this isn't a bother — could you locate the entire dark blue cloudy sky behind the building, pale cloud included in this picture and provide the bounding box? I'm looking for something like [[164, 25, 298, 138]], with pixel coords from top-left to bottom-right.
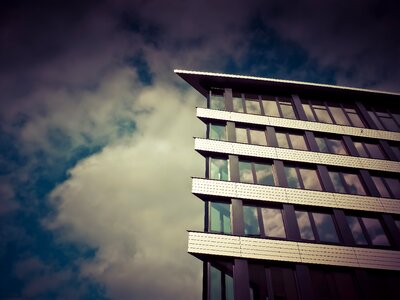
[[0, 0, 400, 300]]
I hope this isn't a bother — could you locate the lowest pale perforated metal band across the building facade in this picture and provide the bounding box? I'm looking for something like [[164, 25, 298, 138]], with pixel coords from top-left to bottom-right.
[[188, 232, 400, 270]]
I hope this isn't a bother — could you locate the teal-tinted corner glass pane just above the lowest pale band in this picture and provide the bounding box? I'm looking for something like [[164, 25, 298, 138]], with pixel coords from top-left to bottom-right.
[[210, 202, 231, 234]]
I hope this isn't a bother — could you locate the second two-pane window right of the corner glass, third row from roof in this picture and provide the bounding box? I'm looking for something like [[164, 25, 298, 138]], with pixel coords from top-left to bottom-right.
[[284, 166, 322, 191]]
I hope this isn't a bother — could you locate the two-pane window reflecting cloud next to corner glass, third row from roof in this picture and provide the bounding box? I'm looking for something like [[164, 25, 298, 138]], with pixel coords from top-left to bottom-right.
[[239, 161, 275, 185]]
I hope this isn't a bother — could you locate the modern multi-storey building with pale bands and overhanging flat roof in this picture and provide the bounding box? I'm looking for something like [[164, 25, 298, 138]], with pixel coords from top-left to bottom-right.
[[175, 70, 400, 300]]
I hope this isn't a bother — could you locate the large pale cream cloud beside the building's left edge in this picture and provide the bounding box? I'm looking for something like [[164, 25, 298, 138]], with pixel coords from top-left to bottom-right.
[[46, 81, 204, 299]]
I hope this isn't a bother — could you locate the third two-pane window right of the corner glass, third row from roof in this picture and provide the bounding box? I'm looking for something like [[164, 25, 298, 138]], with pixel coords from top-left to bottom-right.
[[329, 171, 366, 195]]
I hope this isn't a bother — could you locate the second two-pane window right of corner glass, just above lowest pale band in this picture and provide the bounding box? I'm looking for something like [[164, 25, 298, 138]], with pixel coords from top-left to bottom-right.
[[295, 210, 339, 243]]
